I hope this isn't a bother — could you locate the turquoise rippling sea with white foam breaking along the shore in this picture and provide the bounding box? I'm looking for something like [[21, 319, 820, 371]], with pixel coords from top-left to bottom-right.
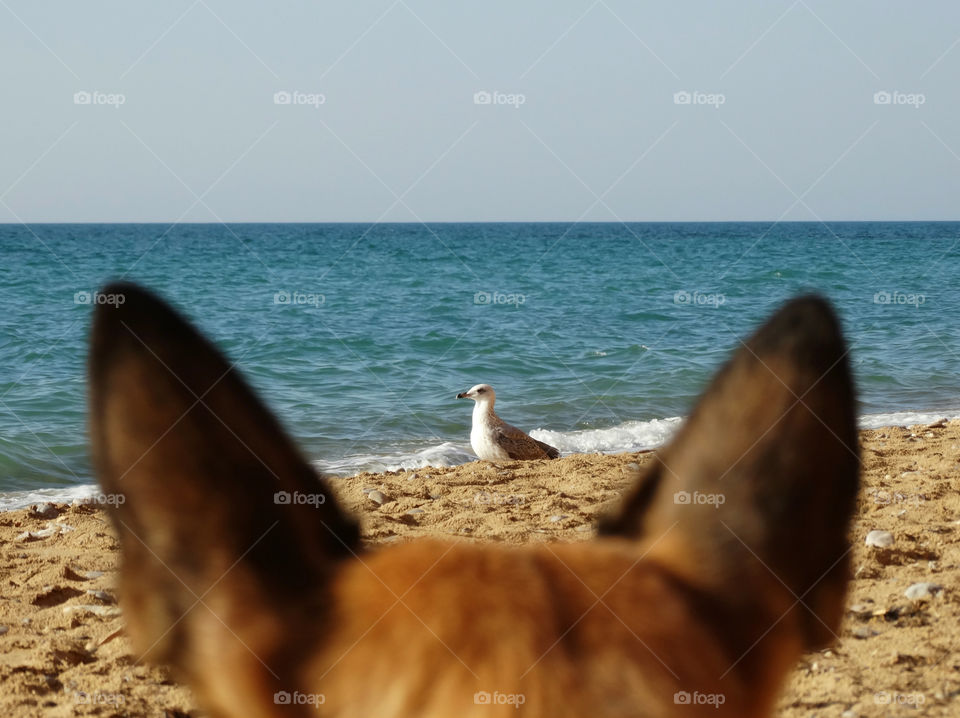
[[0, 223, 960, 504]]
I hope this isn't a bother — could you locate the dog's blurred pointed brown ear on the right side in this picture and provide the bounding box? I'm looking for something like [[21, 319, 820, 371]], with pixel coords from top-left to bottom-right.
[[601, 296, 860, 648]]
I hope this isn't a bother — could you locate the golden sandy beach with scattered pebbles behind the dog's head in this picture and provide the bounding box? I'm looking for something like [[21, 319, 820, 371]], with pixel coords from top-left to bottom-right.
[[0, 422, 960, 718]]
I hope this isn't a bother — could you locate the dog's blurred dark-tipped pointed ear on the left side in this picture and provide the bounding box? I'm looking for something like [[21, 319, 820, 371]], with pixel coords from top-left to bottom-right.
[[89, 284, 358, 663]]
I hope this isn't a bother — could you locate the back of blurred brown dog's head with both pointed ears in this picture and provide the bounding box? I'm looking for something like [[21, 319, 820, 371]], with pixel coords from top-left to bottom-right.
[[90, 284, 859, 718]]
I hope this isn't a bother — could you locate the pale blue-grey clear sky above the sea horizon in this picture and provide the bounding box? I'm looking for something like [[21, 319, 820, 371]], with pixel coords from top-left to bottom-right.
[[0, 0, 960, 222]]
